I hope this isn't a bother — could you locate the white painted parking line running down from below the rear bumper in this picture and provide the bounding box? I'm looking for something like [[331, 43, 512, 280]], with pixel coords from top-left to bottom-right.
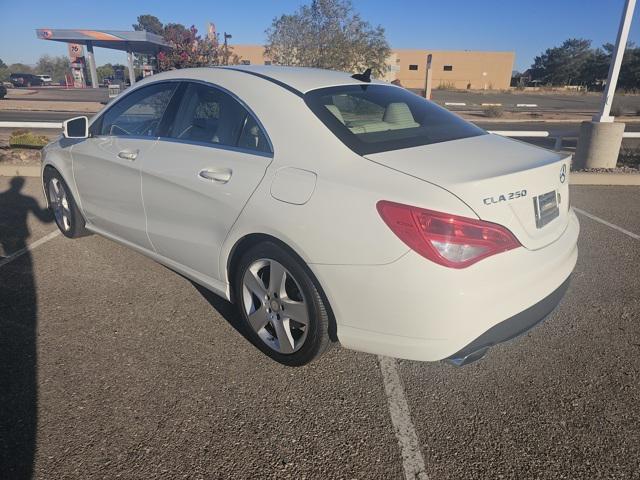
[[378, 355, 429, 480]]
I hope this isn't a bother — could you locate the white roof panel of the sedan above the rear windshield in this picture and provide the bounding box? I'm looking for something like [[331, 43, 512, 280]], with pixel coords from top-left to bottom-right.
[[223, 65, 379, 93]]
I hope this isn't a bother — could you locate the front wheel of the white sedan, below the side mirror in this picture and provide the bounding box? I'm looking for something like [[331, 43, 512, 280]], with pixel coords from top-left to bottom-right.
[[43, 168, 89, 238]]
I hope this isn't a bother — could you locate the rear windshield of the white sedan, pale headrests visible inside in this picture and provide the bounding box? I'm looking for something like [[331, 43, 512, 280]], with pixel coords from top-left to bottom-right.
[[304, 85, 487, 155]]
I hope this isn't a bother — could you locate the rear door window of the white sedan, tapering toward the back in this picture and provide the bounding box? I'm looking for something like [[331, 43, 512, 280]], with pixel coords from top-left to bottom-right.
[[168, 83, 270, 152]]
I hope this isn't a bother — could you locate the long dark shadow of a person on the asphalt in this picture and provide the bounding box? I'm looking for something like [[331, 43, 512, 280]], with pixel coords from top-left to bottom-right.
[[0, 177, 53, 479]]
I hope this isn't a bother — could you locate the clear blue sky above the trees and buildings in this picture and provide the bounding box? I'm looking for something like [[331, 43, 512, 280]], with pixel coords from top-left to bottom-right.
[[0, 0, 640, 71]]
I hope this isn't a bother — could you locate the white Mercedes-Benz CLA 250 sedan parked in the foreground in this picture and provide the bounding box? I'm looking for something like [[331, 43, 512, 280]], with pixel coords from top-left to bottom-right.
[[42, 66, 579, 365]]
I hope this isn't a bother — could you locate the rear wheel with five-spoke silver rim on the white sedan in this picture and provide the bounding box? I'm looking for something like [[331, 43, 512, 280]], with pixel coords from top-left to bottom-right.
[[233, 242, 331, 367]]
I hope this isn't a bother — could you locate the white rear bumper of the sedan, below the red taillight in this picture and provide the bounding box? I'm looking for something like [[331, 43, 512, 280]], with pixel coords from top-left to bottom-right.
[[310, 208, 580, 363]]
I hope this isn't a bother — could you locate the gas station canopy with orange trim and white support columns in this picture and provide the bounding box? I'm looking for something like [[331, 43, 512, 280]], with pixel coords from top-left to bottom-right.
[[36, 28, 172, 88]]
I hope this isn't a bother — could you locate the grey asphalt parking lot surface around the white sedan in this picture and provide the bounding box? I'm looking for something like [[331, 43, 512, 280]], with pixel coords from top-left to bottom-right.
[[0, 177, 640, 479]]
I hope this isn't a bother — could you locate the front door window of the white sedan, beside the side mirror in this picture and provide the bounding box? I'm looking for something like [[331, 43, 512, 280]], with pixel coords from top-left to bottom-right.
[[99, 82, 178, 137]]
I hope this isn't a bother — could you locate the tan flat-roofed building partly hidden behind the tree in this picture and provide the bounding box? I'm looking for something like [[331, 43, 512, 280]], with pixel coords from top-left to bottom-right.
[[233, 45, 515, 90]]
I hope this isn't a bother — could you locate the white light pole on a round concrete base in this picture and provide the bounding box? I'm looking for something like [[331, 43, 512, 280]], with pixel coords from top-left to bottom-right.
[[575, 0, 636, 168]]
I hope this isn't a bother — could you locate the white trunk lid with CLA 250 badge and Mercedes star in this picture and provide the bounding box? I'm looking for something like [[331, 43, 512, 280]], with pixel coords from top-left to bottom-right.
[[366, 134, 571, 250]]
